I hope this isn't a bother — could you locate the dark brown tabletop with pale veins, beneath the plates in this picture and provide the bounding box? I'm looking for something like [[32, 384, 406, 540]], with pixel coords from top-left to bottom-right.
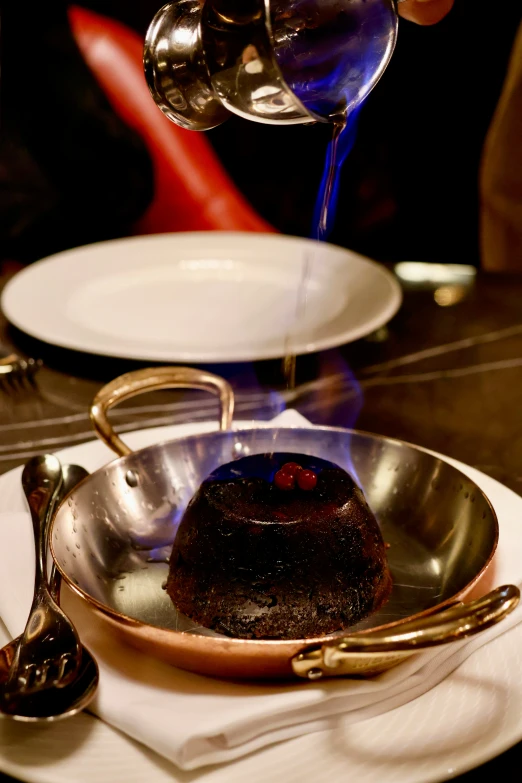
[[0, 268, 522, 783]]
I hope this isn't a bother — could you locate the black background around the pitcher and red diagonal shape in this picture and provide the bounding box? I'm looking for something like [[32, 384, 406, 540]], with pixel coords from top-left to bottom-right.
[[0, 0, 521, 266]]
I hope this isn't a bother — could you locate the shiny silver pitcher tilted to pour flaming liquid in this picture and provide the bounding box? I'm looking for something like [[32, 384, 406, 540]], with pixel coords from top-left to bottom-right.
[[144, 0, 398, 130]]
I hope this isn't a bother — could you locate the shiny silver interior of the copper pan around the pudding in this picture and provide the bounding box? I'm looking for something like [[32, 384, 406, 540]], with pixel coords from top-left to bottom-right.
[[51, 428, 498, 635]]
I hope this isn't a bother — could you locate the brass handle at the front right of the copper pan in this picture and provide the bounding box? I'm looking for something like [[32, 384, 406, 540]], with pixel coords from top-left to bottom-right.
[[292, 585, 520, 680]]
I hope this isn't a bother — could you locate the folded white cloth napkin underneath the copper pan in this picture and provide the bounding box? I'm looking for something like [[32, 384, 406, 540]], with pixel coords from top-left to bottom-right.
[[0, 460, 522, 770]]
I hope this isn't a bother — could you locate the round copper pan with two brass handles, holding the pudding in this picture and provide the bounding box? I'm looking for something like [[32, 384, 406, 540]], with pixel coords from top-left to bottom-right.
[[51, 367, 520, 679]]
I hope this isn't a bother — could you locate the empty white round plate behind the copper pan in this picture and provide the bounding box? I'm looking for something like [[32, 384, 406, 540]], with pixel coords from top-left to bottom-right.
[[1, 231, 402, 364]]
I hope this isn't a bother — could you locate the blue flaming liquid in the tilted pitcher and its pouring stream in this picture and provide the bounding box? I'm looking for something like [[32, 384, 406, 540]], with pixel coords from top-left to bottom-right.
[[270, 0, 397, 240]]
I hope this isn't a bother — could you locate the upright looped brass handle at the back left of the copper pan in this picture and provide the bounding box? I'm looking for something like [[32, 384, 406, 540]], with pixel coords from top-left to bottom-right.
[[91, 367, 234, 457]]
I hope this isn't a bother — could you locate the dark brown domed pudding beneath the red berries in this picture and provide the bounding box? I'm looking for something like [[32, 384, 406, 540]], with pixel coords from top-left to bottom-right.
[[167, 453, 391, 639]]
